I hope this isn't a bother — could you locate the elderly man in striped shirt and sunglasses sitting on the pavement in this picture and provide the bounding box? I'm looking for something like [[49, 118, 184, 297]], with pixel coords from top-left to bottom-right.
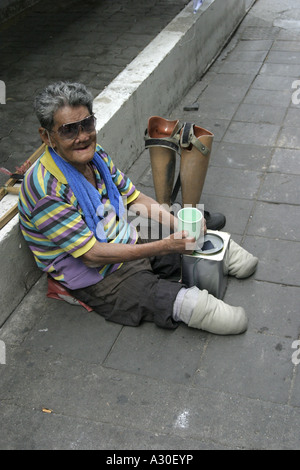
[[19, 82, 258, 335]]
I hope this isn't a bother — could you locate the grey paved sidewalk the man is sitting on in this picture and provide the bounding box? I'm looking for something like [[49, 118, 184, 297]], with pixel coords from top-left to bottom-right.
[[0, 0, 300, 453]]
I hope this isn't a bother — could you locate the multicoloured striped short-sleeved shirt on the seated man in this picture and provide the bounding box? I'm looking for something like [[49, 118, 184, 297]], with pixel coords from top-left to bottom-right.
[[19, 145, 140, 289]]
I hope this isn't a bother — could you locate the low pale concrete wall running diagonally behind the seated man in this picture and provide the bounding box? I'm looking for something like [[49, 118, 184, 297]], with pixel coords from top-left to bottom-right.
[[0, 0, 254, 327]]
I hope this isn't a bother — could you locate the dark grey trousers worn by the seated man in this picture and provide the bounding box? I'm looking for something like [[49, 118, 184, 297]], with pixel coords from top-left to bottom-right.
[[70, 254, 183, 329]]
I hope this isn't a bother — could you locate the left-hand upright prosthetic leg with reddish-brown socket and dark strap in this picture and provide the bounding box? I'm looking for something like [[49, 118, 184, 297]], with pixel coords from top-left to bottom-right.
[[145, 116, 181, 206]]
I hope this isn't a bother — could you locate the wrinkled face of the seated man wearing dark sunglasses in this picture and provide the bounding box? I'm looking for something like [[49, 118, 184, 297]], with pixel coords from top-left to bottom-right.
[[44, 106, 96, 169]]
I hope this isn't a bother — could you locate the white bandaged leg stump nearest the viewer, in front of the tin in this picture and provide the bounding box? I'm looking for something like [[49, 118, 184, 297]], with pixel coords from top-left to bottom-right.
[[185, 289, 248, 335]]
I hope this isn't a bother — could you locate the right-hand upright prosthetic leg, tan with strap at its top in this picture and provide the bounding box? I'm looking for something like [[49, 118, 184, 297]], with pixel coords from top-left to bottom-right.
[[180, 122, 214, 207]]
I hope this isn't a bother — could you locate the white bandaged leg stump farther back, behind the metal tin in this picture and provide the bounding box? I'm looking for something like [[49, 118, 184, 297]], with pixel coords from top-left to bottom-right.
[[226, 239, 258, 279]]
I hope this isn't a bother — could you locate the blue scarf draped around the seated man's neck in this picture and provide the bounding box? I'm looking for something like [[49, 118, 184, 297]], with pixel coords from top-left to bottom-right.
[[48, 147, 125, 243]]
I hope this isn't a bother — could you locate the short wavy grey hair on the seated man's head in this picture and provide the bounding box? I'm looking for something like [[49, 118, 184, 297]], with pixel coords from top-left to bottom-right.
[[34, 82, 93, 131]]
